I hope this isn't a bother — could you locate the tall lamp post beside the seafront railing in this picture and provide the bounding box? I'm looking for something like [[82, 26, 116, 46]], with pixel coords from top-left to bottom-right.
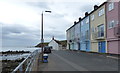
[[41, 11, 51, 62]]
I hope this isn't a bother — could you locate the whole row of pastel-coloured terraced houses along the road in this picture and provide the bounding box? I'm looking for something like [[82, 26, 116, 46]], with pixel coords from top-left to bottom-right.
[[67, 0, 120, 54]]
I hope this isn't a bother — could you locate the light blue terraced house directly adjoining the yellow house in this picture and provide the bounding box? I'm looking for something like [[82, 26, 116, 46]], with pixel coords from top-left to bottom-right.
[[80, 12, 90, 51]]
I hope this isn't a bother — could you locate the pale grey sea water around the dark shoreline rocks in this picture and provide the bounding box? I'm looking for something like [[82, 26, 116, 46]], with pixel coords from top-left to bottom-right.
[[0, 47, 41, 60]]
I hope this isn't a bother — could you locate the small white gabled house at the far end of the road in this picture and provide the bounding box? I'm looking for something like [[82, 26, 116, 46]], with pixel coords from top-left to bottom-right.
[[48, 37, 62, 50]]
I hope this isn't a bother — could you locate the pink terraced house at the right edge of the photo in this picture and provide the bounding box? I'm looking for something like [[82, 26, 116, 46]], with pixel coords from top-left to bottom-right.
[[106, 1, 120, 54]]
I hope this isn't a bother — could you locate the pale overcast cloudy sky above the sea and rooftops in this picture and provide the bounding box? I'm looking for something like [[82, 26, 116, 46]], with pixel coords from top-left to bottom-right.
[[0, 0, 106, 46]]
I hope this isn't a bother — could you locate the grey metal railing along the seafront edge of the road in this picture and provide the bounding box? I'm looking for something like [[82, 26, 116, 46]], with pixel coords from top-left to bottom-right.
[[12, 49, 40, 73]]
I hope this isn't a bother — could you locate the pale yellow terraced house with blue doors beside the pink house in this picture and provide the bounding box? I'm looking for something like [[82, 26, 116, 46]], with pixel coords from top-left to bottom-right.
[[90, 2, 107, 53]]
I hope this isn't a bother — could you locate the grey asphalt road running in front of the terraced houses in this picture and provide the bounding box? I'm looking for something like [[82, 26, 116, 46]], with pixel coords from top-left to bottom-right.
[[39, 50, 118, 71]]
